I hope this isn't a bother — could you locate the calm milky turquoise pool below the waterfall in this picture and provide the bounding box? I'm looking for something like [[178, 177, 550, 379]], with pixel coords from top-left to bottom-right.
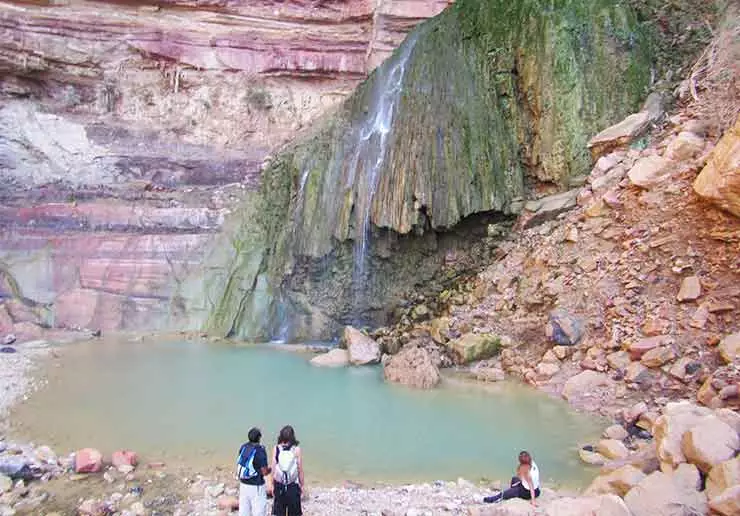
[[12, 340, 603, 486]]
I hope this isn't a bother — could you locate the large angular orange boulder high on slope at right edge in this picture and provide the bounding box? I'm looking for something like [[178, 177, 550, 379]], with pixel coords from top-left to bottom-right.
[[694, 117, 740, 217]]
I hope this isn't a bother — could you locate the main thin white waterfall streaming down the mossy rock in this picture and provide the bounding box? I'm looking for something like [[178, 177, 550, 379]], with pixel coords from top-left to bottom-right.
[[345, 34, 418, 322]]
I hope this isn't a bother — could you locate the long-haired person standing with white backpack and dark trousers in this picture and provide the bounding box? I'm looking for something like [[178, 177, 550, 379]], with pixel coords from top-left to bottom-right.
[[272, 425, 305, 516]]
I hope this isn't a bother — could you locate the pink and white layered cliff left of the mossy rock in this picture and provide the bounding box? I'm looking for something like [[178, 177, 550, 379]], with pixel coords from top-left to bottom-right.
[[0, 0, 447, 338]]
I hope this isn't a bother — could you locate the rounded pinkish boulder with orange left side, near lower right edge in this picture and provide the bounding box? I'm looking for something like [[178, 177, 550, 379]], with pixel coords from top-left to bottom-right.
[[681, 415, 740, 473]]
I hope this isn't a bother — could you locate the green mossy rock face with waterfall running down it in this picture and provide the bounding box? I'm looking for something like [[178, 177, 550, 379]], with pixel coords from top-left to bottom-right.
[[199, 0, 650, 338]]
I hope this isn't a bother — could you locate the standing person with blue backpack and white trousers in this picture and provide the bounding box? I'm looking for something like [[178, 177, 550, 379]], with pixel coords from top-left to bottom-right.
[[236, 428, 270, 516]]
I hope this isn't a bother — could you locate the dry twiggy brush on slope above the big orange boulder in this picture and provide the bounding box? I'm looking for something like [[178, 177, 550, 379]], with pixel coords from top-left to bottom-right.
[[682, 7, 740, 132]]
